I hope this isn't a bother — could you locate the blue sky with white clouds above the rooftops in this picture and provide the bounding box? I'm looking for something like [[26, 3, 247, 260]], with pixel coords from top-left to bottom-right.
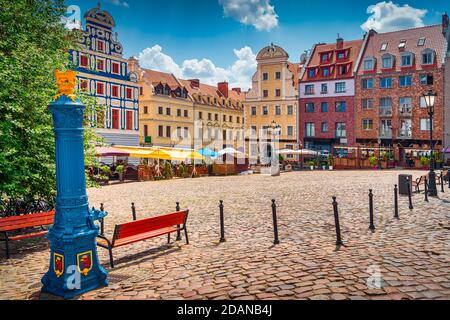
[[66, 0, 450, 88]]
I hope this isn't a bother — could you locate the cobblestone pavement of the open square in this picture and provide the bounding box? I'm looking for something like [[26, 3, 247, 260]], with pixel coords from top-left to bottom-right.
[[0, 171, 450, 300]]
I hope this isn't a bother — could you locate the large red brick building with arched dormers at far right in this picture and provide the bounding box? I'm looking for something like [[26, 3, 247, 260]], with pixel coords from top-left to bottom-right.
[[355, 16, 448, 165]]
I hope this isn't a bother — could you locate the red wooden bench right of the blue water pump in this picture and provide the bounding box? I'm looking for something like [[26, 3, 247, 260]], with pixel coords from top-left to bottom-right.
[[97, 210, 189, 268]]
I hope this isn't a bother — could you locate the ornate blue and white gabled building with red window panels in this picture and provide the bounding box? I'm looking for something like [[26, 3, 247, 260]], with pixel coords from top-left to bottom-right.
[[69, 5, 139, 146]]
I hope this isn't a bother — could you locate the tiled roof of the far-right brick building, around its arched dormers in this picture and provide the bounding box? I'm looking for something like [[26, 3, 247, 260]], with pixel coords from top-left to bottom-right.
[[358, 25, 446, 75]]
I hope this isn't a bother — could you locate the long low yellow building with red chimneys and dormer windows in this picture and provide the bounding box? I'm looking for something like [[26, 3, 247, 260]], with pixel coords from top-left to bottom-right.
[[129, 58, 245, 151]]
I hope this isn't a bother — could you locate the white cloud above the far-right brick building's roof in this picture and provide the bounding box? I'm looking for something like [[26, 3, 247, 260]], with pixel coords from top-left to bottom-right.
[[361, 1, 428, 32]]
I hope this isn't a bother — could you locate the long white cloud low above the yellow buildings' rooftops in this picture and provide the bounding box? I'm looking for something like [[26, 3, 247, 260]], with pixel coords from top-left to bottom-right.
[[138, 45, 257, 90]]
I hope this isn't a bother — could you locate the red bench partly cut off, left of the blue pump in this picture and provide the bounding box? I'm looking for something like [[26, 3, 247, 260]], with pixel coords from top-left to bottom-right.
[[0, 210, 55, 259]]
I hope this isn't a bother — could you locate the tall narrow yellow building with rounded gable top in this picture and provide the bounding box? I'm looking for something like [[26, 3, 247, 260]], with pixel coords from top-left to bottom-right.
[[244, 44, 302, 162]]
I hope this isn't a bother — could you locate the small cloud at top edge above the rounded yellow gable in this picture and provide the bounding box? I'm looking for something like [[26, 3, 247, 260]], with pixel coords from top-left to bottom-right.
[[219, 0, 278, 31]]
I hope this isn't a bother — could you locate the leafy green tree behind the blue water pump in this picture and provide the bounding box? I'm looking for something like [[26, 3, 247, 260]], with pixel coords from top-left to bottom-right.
[[0, 0, 103, 204]]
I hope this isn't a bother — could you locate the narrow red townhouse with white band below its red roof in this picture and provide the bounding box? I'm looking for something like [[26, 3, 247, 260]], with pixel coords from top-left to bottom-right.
[[298, 37, 363, 153]]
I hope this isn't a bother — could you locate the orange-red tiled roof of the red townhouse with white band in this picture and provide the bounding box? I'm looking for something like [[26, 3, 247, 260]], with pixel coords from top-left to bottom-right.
[[302, 40, 363, 81]]
